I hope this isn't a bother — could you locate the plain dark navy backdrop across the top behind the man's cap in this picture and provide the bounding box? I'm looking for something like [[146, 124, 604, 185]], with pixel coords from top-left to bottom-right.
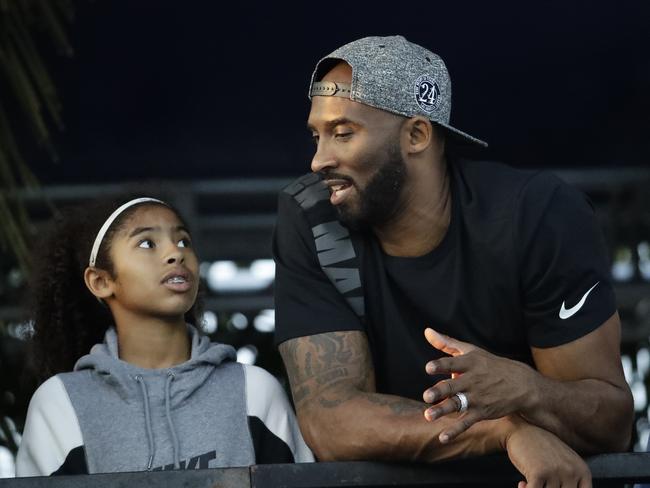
[[28, 0, 650, 184]]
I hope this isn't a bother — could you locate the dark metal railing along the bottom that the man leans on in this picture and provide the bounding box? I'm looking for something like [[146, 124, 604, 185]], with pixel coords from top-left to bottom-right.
[[0, 453, 650, 488]]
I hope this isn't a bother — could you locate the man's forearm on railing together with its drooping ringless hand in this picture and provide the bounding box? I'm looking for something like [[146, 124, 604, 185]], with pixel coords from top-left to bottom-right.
[[303, 392, 591, 487]]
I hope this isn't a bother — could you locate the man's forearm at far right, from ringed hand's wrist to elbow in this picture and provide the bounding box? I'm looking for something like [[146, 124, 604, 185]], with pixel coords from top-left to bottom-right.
[[521, 374, 633, 454]]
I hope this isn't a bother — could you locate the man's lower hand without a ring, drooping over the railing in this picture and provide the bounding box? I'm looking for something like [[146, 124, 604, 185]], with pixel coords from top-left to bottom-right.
[[505, 419, 591, 488]]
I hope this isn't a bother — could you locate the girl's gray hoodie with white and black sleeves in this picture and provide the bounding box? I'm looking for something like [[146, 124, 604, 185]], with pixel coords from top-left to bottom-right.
[[16, 326, 313, 476]]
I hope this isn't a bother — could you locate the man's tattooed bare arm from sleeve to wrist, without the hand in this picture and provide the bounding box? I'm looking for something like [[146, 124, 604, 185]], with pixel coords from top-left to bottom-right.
[[280, 331, 523, 462]]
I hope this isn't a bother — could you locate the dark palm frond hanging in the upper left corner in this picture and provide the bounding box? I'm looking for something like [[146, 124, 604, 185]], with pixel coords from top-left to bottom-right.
[[0, 0, 74, 272]]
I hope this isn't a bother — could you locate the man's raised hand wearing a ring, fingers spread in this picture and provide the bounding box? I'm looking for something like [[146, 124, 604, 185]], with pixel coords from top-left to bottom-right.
[[422, 328, 538, 443]]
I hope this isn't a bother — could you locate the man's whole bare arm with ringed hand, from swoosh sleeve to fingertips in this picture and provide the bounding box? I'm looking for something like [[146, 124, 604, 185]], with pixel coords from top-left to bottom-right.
[[423, 313, 634, 454]]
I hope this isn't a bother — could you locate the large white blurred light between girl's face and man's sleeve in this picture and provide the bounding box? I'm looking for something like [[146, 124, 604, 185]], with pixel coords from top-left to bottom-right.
[[206, 259, 275, 293]]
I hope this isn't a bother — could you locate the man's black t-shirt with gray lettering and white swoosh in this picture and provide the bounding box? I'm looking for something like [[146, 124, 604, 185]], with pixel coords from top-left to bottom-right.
[[273, 160, 616, 400]]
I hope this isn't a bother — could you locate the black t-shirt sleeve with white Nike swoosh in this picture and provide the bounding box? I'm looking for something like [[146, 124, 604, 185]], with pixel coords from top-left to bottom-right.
[[514, 173, 616, 348]]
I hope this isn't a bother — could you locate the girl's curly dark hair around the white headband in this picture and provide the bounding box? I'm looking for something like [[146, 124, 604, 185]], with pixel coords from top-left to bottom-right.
[[29, 194, 199, 382]]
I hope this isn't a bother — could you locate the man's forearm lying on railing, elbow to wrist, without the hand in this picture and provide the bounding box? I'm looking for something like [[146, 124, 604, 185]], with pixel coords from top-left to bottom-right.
[[299, 389, 511, 462]]
